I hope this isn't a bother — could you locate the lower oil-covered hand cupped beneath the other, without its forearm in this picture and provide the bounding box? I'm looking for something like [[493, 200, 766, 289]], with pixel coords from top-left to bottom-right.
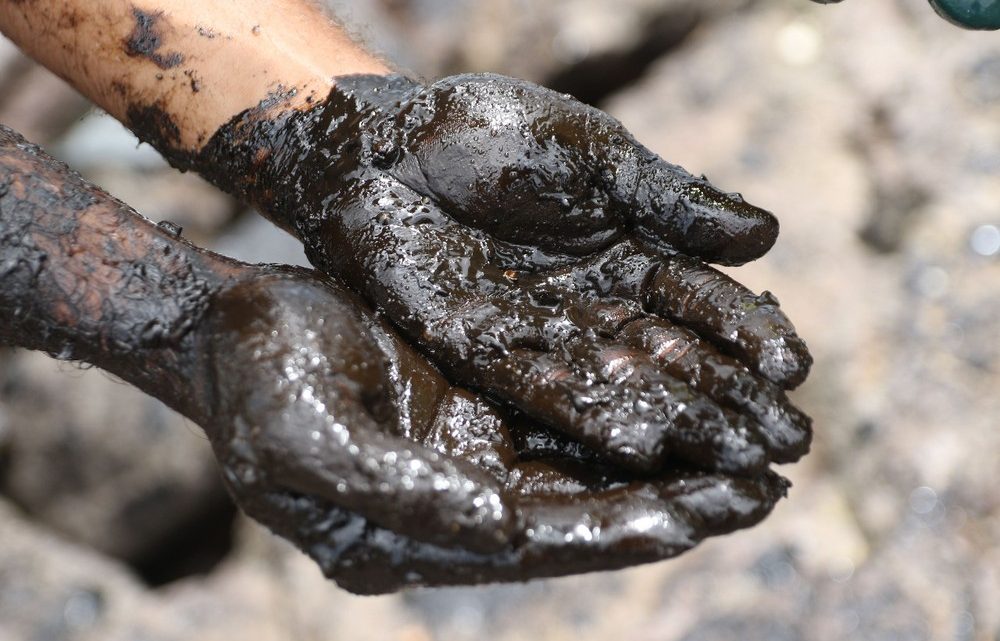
[[207, 270, 786, 594]]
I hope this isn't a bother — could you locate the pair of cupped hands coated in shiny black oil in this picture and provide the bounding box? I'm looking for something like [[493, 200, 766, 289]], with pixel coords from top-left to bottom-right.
[[5, 75, 811, 593]]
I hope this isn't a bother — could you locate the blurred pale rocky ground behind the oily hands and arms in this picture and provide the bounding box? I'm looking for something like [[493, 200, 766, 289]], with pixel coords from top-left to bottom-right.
[[0, 0, 1000, 641]]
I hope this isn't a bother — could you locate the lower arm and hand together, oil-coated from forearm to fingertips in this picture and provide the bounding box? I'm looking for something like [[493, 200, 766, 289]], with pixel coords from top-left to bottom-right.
[[0, 127, 787, 594]]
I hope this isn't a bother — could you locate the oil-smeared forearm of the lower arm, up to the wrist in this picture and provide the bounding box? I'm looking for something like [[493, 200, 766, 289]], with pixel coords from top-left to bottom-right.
[[0, 126, 239, 420]]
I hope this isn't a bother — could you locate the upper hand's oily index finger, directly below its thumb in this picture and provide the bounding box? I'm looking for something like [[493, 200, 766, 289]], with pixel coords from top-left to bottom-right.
[[644, 256, 812, 389]]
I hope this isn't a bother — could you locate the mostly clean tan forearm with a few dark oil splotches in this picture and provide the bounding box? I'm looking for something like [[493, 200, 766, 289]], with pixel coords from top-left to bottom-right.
[[0, 0, 388, 154]]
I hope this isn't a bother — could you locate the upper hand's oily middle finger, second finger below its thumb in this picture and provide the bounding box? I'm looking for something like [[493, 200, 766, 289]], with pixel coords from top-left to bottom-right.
[[617, 317, 812, 463]]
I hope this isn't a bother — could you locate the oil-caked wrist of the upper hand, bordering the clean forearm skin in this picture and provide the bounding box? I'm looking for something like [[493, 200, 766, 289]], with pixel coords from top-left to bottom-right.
[[189, 74, 422, 232]]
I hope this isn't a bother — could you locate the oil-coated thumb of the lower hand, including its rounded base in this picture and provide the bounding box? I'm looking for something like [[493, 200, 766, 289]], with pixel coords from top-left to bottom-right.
[[207, 274, 516, 551]]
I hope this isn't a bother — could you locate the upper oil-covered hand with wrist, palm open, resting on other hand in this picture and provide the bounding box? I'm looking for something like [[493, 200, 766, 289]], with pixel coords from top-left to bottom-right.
[[197, 75, 811, 474]]
